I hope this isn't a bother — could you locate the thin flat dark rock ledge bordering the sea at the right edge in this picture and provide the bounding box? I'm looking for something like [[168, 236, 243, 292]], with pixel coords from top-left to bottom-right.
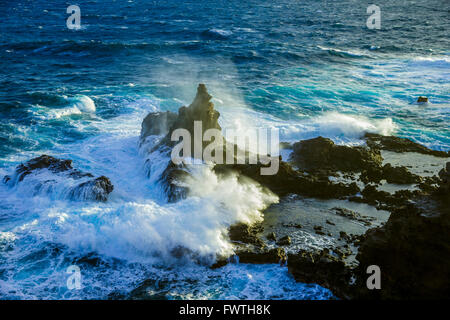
[[364, 133, 450, 158]]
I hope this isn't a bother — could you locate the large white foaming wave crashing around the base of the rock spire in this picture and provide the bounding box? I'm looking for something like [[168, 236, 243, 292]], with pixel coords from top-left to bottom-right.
[[3, 106, 278, 264]]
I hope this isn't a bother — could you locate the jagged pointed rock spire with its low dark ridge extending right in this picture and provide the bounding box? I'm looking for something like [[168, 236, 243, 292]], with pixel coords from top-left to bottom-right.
[[141, 84, 362, 202]]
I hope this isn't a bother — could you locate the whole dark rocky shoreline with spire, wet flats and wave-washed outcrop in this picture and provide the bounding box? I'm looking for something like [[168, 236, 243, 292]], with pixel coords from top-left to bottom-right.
[[3, 85, 450, 299]]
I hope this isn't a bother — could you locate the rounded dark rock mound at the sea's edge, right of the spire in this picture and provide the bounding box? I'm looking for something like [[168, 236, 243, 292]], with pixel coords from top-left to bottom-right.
[[291, 137, 383, 172]]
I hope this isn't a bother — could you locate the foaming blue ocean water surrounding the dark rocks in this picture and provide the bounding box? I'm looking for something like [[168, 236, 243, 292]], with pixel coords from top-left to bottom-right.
[[0, 0, 450, 299]]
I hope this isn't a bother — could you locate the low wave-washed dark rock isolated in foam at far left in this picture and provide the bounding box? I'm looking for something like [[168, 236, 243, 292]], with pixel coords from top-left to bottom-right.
[[3, 155, 114, 201]]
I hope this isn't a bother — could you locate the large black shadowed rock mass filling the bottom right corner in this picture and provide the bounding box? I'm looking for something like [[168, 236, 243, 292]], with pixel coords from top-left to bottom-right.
[[354, 198, 450, 300]]
